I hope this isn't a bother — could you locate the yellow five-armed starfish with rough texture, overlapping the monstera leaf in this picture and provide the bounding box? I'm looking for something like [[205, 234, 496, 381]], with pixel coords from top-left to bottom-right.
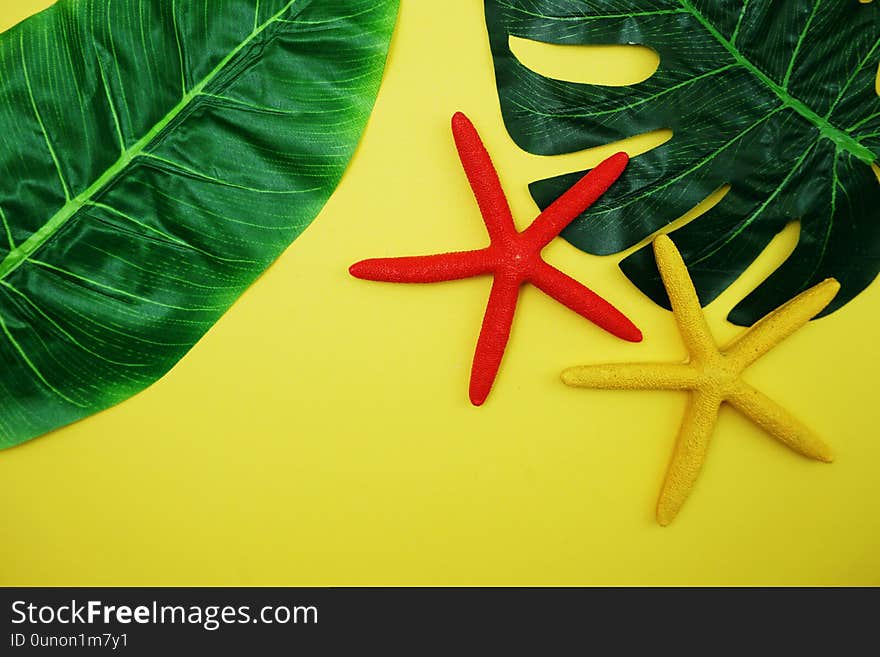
[[562, 235, 840, 526]]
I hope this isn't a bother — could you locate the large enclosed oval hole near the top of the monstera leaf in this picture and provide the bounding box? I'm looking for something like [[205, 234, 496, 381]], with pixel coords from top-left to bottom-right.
[[510, 36, 660, 87]]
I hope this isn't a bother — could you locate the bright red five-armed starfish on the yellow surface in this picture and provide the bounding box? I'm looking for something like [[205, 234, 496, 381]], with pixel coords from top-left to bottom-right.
[[349, 112, 642, 406]]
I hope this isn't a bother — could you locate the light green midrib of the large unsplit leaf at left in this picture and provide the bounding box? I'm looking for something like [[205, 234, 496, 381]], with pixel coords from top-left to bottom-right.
[[0, 0, 301, 281]]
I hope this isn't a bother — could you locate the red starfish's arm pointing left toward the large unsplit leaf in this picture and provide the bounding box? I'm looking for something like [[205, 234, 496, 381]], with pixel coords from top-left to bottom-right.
[[349, 249, 495, 283]]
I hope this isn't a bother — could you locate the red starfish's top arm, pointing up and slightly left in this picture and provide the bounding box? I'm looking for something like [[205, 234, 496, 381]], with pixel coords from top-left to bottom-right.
[[452, 112, 516, 242]]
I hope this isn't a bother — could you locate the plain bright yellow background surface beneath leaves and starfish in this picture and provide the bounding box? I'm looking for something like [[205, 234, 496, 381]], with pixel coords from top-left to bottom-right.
[[0, 0, 880, 585]]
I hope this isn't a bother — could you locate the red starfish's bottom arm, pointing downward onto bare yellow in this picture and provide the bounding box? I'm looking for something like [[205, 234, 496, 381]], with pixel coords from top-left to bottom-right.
[[470, 276, 520, 406]]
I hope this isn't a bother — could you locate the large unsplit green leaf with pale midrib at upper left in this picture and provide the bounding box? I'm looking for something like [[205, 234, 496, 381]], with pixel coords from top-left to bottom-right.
[[0, 0, 398, 447]]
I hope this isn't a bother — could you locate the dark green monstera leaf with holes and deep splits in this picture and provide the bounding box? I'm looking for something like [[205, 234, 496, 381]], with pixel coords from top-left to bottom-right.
[[486, 0, 880, 324]]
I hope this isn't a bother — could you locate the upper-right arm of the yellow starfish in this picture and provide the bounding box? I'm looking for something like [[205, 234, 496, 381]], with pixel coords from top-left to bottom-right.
[[725, 278, 840, 371]]
